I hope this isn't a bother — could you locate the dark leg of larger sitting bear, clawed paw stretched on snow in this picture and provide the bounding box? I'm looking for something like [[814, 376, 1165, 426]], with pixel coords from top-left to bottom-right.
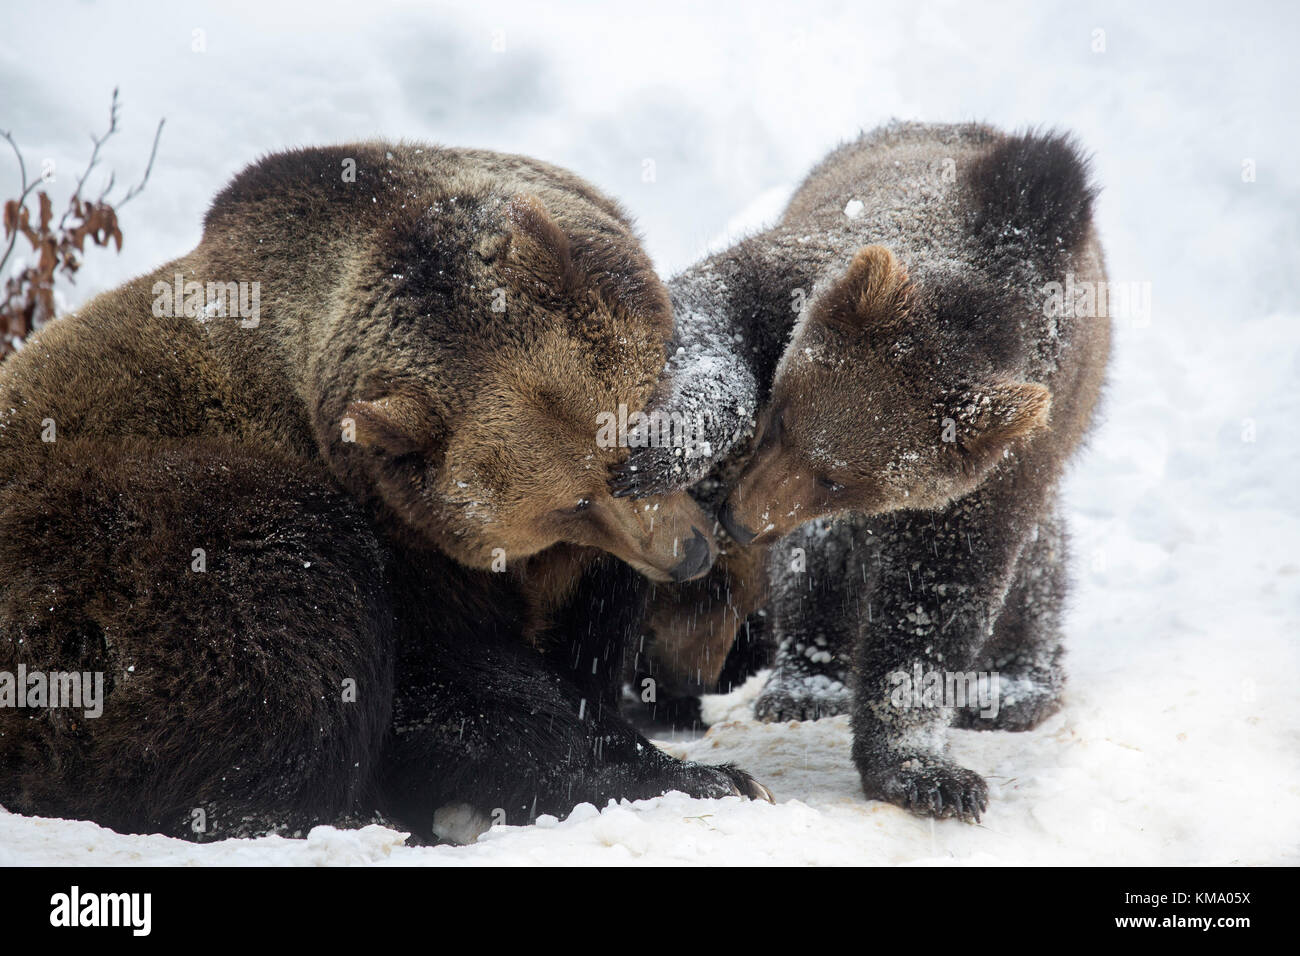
[[381, 558, 770, 838]]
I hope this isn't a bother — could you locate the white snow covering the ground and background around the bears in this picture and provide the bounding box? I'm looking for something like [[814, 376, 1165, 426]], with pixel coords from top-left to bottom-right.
[[0, 1, 1300, 865]]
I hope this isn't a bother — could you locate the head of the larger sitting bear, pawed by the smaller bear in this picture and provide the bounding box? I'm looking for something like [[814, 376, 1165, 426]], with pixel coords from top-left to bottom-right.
[[315, 193, 715, 580]]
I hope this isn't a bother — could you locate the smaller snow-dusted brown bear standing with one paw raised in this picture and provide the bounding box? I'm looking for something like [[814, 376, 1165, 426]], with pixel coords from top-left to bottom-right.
[[619, 124, 1109, 819]]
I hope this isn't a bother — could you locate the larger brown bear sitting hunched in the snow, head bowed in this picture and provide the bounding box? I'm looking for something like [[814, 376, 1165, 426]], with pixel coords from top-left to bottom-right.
[[0, 142, 767, 838]]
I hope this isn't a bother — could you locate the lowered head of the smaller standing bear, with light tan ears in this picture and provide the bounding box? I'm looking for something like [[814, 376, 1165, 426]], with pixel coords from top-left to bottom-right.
[[720, 246, 1052, 544]]
